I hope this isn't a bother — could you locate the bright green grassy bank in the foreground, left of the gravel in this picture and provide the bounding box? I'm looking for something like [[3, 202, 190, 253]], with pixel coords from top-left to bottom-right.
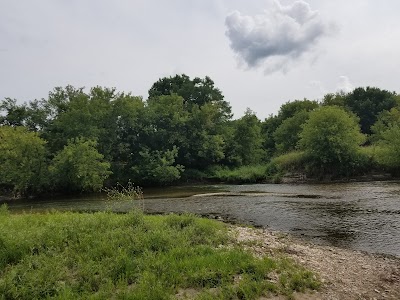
[[0, 206, 319, 299]]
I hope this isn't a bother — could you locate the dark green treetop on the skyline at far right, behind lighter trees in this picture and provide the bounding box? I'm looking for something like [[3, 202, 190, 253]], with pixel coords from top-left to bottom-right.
[[345, 87, 396, 134]]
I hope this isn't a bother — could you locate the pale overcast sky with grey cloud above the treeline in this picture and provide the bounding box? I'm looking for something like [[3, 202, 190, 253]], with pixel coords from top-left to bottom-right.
[[0, 0, 400, 119]]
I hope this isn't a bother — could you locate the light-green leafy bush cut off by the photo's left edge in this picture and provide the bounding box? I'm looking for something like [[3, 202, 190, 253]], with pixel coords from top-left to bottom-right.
[[0, 126, 47, 195]]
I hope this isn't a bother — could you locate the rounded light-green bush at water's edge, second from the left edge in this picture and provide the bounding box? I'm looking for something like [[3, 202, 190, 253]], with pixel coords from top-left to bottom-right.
[[50, 138, 111, 192]]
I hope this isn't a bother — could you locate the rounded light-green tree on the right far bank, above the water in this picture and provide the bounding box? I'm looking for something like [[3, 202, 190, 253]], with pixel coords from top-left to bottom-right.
[[299, 106, 365, 176]]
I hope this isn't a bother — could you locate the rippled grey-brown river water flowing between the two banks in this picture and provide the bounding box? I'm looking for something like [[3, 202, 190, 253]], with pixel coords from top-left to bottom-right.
[[3, 181, 400, 257]]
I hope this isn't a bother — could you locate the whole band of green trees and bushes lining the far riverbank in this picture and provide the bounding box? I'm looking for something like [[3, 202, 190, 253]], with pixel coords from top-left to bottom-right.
[[0, 75, 400, 195]]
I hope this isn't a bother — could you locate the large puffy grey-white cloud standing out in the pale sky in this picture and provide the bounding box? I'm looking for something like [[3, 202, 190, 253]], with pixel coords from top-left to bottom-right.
[[225, 0, 331, 72]]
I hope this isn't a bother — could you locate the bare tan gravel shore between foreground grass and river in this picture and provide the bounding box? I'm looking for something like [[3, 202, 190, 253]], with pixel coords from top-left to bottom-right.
[[231, 226, 400, 300]]
